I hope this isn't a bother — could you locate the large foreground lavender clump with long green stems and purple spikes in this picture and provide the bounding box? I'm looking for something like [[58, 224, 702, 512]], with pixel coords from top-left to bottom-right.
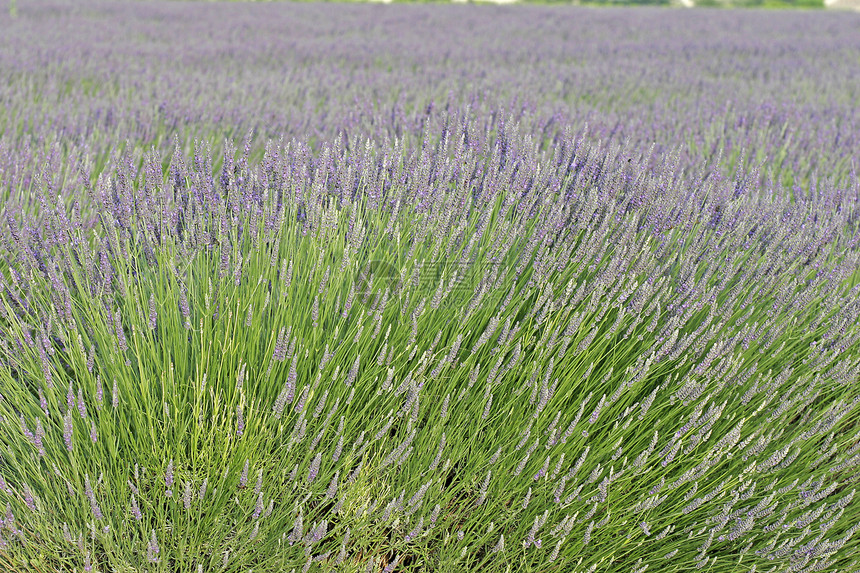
[[0, 108, 860, 573]]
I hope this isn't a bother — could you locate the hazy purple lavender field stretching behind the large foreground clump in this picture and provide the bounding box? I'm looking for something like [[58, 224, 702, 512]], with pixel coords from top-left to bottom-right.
[[0, 0, 860, 207]]
